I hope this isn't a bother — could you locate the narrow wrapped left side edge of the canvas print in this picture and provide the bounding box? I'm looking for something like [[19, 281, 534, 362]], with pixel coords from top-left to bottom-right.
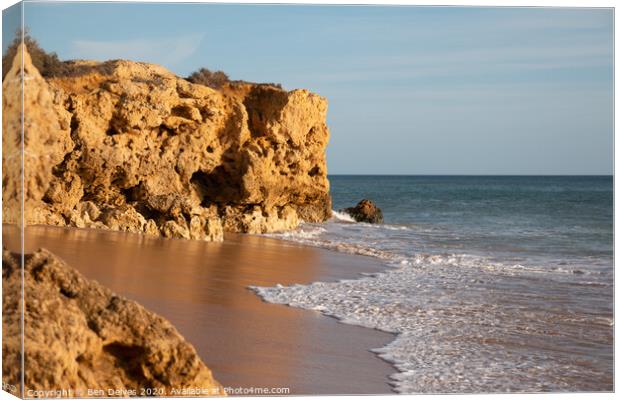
[[2, 3, 24, 397]]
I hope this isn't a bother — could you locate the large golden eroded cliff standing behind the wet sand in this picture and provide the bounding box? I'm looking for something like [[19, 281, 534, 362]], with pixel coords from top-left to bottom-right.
[[3, 46, 331, 240]]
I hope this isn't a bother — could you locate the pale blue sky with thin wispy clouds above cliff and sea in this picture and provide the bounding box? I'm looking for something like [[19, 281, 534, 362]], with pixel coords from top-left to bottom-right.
[[2, 2, 613, 175]]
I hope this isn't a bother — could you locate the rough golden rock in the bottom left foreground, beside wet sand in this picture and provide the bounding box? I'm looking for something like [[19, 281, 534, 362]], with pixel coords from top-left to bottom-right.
[[2, 250, 224, 397]]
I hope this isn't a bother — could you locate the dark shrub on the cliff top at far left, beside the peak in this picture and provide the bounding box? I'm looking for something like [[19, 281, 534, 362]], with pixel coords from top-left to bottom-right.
[[2, 30, 69, 79]]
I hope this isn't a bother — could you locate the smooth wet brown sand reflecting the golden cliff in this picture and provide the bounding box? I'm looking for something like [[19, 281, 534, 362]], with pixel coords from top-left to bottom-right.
[[3, 226, 395, 394]]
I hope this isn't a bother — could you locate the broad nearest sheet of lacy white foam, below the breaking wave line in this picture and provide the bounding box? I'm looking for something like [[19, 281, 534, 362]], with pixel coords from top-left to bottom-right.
[[253, 255, 610, 393]]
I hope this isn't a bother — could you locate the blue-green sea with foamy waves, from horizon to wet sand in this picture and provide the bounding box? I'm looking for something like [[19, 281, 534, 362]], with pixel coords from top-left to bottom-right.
[[253, 175, 614, 393]]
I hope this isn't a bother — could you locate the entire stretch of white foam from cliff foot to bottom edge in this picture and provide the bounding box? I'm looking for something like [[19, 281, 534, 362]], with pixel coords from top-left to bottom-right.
[[252, 218, 613, 393]]
